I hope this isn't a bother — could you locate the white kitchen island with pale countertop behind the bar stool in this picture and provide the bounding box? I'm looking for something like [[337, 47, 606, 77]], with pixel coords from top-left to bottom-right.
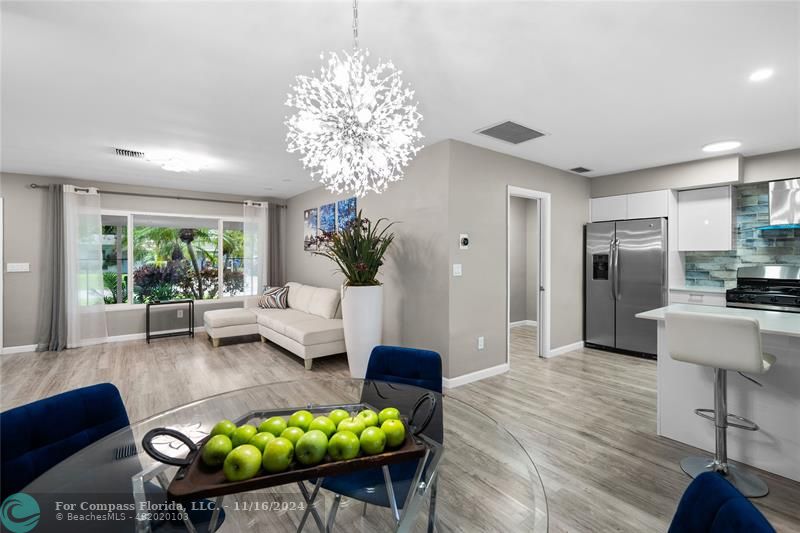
[[636, 304, 800, 481]]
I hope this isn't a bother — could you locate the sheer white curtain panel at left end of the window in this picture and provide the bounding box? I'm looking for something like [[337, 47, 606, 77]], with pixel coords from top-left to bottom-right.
[[64, 185, 108, 348]]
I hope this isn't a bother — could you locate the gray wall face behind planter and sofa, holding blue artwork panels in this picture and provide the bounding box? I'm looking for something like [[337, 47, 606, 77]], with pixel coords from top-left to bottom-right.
[[286, 141, 449, 375]]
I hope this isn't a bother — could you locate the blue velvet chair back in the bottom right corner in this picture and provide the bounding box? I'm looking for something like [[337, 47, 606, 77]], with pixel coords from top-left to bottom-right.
[[669, 472, 775, 533]]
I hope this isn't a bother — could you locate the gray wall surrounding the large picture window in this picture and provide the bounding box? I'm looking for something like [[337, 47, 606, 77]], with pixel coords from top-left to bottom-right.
[[0, 173, 268, 346]]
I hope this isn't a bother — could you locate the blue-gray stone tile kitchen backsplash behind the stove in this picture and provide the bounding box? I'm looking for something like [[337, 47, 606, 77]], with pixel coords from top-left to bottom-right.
[[684, 182, 800, 288]]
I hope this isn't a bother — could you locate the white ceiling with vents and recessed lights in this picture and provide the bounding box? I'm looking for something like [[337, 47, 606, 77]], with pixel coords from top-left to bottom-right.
[[1, 0, 800, 197]]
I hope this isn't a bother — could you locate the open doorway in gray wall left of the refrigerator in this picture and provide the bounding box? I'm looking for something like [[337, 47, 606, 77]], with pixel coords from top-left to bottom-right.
[[506, 187, 550, 364]]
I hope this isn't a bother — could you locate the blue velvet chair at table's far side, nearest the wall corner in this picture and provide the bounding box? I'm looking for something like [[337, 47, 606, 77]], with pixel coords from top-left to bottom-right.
[[322, 346, 442, 530]]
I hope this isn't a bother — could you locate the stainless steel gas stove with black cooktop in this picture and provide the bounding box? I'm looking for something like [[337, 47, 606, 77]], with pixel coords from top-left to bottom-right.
[[725, 265, 800, 313]]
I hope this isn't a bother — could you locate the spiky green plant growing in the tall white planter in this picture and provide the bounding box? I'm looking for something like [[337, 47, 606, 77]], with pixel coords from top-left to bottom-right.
[[313, 211, 394, 287]]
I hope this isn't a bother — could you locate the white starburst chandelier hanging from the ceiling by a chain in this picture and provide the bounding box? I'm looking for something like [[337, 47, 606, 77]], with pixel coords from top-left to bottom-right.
[[285, 0, 422, 197]]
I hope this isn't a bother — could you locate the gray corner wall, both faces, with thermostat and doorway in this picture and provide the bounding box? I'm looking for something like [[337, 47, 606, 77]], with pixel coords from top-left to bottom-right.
[[287, 137, 589, 378]]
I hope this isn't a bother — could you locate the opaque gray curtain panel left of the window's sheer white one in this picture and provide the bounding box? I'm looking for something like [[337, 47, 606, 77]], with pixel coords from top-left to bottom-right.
[[36, 185, 67, 352]]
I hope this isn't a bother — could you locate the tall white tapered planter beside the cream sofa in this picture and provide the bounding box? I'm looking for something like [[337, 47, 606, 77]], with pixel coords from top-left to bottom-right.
[[342, 285, 383, 379]]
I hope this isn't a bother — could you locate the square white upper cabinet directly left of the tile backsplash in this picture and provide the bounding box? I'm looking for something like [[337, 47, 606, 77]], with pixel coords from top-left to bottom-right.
[[678, 185, 733, 252]]
